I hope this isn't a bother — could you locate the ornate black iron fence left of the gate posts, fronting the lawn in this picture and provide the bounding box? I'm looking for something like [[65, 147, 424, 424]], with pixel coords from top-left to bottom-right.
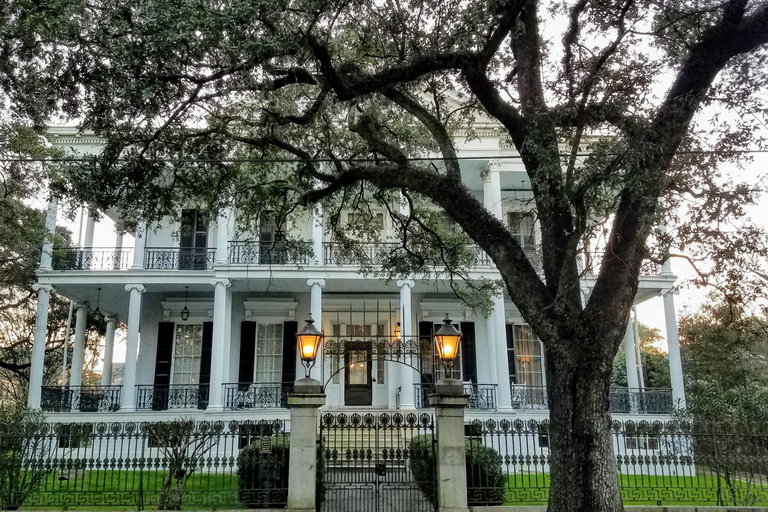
[[0, 420, 290, 510]]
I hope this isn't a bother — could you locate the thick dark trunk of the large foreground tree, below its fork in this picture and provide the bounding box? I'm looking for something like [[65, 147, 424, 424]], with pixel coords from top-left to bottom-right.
[[547, 340, 624, 512]]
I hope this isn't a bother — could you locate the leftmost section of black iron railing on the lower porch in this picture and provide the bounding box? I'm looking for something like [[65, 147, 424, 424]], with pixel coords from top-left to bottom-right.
[[40, 386, 122, 412]]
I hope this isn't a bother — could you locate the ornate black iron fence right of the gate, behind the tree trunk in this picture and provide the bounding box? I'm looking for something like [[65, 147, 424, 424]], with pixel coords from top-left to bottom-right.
[[466, 419, 768, 506]]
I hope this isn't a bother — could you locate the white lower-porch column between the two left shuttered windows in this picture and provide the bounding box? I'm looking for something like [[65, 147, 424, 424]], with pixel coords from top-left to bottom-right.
[[207, 278, 232, 411]]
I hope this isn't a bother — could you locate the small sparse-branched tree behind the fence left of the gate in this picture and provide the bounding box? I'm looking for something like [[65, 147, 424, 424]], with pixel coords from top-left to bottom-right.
[[147, 418, 224, 510]]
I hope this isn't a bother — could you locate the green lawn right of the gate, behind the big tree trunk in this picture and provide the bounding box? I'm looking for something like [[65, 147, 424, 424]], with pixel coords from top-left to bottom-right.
[[504, 473, 768, 506]]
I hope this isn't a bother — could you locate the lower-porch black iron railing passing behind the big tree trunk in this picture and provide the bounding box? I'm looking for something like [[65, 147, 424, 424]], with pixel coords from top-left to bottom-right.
[[511, 384, 674, 414]]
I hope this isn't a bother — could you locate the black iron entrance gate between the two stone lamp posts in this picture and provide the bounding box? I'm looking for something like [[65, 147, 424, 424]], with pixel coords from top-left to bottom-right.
[[317, 413, 437, 512]]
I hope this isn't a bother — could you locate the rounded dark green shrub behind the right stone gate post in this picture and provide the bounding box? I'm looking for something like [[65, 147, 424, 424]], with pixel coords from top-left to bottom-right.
[[411, 436, 507, 506]]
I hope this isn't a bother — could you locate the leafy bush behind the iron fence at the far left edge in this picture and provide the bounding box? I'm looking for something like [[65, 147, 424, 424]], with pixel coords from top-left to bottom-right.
[[0, 403, 50, 510]]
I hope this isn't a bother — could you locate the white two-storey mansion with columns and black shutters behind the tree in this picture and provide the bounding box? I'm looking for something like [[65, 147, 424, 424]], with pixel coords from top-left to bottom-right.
[[29, 125, 684, 422]]
